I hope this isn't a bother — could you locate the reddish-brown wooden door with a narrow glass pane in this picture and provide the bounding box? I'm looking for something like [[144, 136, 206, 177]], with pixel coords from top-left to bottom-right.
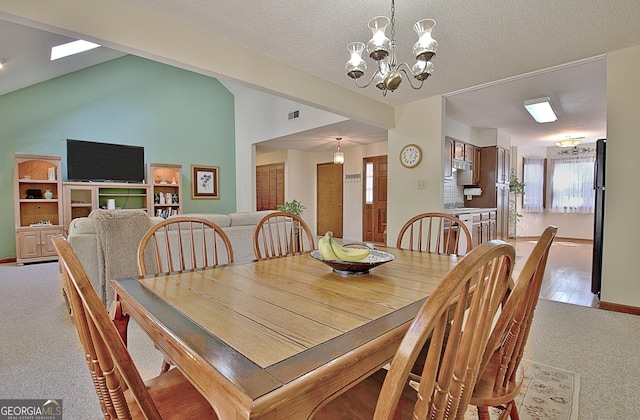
[[362, 156, 387, 244]]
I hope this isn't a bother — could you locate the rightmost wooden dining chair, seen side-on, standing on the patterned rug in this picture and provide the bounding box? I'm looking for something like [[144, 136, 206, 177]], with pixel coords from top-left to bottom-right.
[[470, 225, 558, 420]]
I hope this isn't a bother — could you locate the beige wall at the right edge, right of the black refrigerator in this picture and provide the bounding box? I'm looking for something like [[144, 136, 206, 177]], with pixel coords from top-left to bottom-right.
[[601, 47, 640, 307]]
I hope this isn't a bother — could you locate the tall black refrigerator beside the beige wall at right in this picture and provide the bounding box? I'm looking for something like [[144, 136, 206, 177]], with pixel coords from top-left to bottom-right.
[[591, 139, 607, 298]]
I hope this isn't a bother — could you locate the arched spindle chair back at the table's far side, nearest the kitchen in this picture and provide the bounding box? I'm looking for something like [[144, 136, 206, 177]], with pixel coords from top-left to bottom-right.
[[396, 212, 473, 255]]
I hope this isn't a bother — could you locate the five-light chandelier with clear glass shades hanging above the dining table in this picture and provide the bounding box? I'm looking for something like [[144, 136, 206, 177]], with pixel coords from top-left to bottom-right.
[[346, 0, 438, 96]]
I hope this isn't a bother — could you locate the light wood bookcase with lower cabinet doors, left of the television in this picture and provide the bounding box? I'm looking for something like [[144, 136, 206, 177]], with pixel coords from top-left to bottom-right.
[[13, 154, 62, 265]]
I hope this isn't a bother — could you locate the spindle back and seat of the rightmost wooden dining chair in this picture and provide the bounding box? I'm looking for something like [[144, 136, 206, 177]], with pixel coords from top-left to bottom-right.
[[473, 225, 558, 406]]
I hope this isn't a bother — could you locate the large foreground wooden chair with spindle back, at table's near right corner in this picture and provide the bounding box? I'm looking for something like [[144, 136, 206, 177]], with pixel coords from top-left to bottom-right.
[[314, 240, 515, 420]]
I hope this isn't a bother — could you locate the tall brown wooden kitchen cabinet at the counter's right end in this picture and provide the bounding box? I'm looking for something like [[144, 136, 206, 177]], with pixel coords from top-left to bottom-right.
[[465, 146, 511, 240]]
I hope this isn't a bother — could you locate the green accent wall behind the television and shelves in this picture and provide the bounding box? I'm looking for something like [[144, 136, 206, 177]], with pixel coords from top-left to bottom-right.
[[0, 56, 236, 260]]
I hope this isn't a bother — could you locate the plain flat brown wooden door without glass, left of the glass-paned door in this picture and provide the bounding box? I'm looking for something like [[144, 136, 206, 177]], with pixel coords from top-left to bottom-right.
[[316, 163, 343, 238]]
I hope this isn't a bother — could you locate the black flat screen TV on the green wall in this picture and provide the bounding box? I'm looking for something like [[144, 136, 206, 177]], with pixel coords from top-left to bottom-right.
[[67, 139, 144, 182]]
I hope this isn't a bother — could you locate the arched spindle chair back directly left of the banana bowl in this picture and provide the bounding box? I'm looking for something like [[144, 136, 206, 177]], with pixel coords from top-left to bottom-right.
[[253, 212, 315, 260]]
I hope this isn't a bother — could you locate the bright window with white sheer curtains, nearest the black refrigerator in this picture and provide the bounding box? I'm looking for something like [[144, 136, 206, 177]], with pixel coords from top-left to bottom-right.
[[550, 156, 595, 213]]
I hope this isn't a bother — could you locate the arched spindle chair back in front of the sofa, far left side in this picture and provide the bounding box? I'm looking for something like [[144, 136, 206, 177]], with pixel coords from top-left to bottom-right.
[[137, 216, 234, 276]]
